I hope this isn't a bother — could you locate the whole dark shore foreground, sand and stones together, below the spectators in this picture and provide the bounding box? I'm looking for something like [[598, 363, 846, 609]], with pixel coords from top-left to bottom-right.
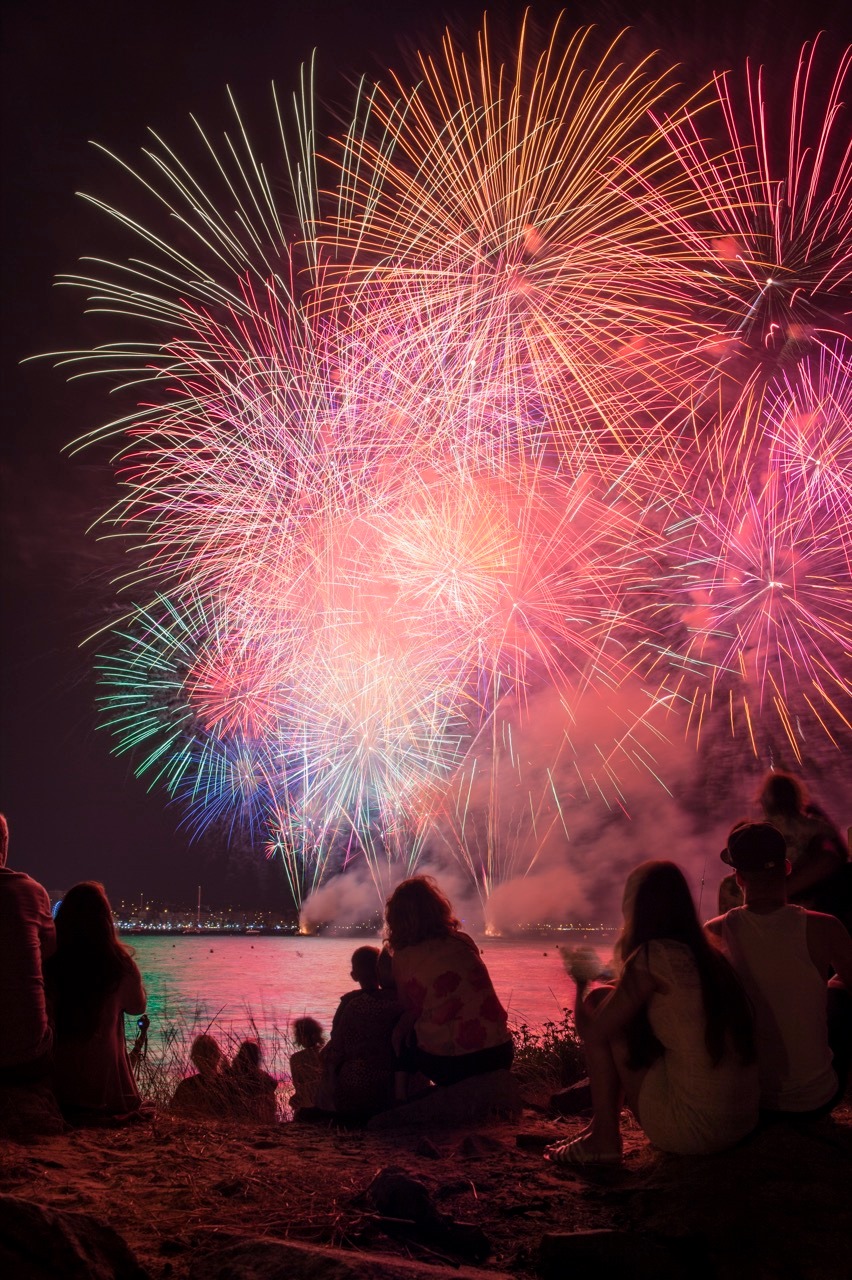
[[0, 1102, 852, 1280]]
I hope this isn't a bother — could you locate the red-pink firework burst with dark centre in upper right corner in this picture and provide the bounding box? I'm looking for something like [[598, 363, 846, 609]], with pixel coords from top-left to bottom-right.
[[639, 38, 852, 358]]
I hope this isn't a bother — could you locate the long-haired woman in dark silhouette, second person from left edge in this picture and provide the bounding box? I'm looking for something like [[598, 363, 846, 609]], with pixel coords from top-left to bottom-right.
[[45, 881, 146, 1119]]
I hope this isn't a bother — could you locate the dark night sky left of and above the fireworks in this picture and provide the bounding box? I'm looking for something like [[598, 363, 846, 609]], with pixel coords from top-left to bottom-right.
[[0, 0, 851, 900]]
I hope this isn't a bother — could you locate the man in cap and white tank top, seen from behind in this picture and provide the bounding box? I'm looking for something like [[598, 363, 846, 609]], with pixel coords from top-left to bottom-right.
[[705, 822, 852, 1119]]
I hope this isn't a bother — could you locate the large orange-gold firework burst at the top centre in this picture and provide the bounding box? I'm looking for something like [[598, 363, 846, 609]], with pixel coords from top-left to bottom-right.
[[326, 16, 711, 470]]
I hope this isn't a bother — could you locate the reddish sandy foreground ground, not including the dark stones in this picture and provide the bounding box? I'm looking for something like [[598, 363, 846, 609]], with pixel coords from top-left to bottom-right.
[[0, 1103, 852, 1280]]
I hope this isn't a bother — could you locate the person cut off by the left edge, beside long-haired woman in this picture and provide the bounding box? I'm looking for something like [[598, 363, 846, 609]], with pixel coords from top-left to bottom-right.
[[0, 813, 56, 1085]]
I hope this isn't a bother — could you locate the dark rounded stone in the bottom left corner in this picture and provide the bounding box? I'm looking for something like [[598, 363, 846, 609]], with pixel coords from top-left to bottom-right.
[[0, 1196, 151, 1280]]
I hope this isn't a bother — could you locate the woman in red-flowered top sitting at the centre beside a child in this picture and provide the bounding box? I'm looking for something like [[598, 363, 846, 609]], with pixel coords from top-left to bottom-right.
[[385, 876, 514, 1084]]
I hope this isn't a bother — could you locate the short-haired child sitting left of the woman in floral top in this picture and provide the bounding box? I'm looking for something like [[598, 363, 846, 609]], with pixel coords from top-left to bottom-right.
[[324, 947, 402, 1119]]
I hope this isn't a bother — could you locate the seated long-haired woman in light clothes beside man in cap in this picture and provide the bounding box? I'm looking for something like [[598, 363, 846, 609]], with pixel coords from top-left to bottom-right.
[[545, 861, 759, 1165]]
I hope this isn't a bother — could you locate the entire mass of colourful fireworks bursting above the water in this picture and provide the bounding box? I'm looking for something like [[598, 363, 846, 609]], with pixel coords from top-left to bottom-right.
[[54, 24, 852, 921]]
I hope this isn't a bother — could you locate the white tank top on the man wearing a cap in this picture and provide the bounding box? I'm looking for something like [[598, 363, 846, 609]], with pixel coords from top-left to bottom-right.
[[719, 905, 837, 1111]]
